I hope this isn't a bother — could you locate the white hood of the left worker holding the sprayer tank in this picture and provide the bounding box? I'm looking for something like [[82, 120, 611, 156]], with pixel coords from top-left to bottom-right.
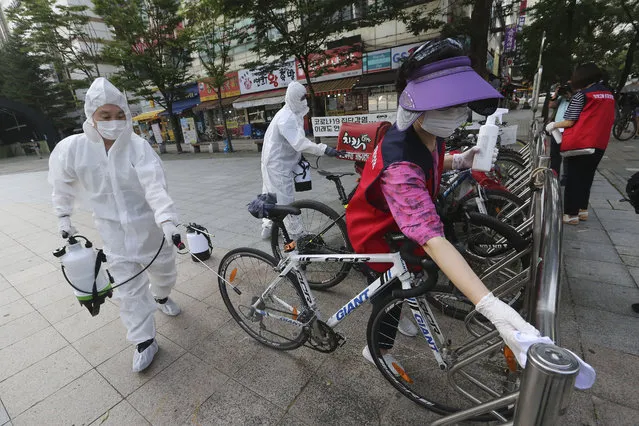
[[82, 77, 133, 143]]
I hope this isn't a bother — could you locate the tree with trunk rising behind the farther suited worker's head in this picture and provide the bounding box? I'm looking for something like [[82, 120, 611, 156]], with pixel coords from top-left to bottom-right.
[[225, 0, 404, 123]]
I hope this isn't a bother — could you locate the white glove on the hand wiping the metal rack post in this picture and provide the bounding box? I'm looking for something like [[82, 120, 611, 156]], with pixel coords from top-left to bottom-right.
[[475, 293, 541, 351]]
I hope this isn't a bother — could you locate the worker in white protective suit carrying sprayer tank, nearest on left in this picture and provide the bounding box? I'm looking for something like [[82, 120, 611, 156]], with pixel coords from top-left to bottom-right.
[[49, 78, 180, 372]]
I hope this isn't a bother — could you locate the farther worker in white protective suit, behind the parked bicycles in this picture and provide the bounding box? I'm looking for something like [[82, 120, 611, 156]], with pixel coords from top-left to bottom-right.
[[262, 81, 338, 239]]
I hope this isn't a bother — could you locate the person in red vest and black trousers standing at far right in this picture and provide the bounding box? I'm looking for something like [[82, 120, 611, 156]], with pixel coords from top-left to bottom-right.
[[546, 62, 615, 225]]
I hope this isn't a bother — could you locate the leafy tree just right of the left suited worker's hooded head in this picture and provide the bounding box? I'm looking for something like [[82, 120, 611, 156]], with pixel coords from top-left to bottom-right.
[[93, 0, 193, 152]]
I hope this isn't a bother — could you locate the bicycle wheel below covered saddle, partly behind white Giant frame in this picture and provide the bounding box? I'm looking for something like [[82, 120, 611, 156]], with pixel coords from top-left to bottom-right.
[[271, 200, 353, 290]]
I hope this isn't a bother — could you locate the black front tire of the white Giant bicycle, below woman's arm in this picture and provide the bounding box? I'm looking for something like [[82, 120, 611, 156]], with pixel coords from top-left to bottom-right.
[[366, 295, 511, 421]]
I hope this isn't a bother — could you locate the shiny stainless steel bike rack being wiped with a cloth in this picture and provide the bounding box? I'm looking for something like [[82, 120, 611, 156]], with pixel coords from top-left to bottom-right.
[[432, 118, 579, 426]]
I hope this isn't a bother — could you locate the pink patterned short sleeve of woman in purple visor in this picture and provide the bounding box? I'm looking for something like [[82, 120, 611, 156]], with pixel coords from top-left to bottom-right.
[[380, 162, 444, 246]]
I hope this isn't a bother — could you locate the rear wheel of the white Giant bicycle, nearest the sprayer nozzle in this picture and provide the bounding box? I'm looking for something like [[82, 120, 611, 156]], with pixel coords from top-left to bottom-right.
[[218, 248, 308, 350]]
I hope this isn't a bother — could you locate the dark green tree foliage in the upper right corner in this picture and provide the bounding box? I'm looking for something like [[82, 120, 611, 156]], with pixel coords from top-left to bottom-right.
[[517, 0, 639, 88]]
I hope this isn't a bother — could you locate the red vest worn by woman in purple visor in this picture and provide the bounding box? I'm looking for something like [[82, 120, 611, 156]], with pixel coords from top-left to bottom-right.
[[346, 125, 445, 272]]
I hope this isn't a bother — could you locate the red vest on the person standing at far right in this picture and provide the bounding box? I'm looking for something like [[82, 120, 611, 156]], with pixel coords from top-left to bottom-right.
[[560, 83, 615, 152]]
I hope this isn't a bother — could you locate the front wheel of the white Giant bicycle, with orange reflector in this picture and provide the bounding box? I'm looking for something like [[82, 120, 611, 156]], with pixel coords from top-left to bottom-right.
[[367, 296, 518, 420]]
